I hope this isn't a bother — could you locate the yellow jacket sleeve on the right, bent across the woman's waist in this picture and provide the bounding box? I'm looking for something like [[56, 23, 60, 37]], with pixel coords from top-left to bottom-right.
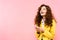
[[43, 20, 56, 39]]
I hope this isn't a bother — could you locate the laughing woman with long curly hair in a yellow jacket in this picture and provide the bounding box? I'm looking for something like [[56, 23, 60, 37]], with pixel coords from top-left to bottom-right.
[[35, 4, 56, 40]]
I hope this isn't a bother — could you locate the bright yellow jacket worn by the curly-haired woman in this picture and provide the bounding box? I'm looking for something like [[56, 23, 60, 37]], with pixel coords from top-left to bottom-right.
[[35, 20, 56, 40]]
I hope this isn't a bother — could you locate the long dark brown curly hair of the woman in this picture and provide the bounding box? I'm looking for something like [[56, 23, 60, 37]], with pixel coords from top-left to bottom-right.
[[35, 4, 54, 26]]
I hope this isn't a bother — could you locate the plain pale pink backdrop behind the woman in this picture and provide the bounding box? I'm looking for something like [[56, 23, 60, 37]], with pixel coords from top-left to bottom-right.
[[0, 0, 60, 40]]
